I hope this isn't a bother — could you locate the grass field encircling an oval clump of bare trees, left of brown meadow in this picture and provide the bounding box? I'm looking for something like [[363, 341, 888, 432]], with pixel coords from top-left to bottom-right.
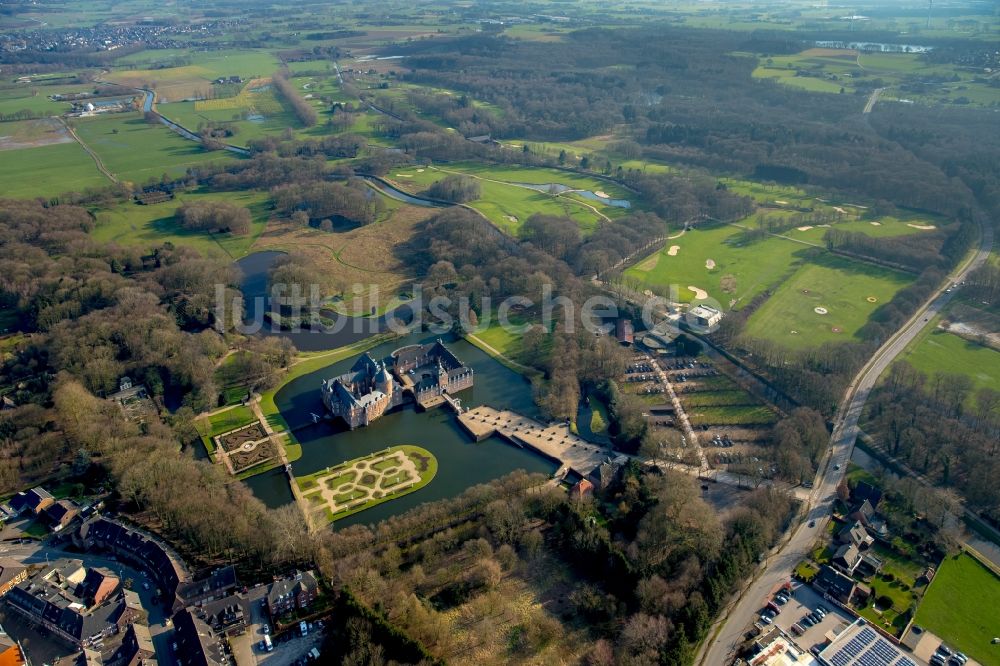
[[92, 190, 269, 259]]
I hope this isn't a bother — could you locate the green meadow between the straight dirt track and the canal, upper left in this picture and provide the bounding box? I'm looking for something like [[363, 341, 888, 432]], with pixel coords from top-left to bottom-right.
[[74, 113, 236, 184]]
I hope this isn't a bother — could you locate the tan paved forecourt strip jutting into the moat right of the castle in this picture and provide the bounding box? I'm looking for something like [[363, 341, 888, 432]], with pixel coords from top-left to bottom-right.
[[458, 405, 608, 476]]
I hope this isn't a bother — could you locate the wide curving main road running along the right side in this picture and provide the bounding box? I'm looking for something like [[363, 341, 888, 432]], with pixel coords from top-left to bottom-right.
[[698, 219, 993, 666]]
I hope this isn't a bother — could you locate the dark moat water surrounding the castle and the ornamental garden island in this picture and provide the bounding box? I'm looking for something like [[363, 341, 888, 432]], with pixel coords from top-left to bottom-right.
[[240, 253, 558, 527]]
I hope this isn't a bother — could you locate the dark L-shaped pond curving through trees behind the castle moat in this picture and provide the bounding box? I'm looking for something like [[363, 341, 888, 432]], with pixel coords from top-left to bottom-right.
[[236, 250, 412, 351]]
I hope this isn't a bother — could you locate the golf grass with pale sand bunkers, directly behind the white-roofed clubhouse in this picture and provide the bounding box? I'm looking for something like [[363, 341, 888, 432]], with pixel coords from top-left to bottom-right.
[[625, 225, 819, 309]]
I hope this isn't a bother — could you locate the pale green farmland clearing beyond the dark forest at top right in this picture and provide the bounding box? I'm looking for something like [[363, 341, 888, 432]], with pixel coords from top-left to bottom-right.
[[753, 48, 1000, 106]]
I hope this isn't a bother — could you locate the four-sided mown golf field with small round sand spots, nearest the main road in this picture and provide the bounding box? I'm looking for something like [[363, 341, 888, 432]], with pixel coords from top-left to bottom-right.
[[746, 254, 912, 349]]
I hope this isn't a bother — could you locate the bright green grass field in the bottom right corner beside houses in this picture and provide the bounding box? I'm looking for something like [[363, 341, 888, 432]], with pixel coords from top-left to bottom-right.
[[914, 553, 1000, 666]]
